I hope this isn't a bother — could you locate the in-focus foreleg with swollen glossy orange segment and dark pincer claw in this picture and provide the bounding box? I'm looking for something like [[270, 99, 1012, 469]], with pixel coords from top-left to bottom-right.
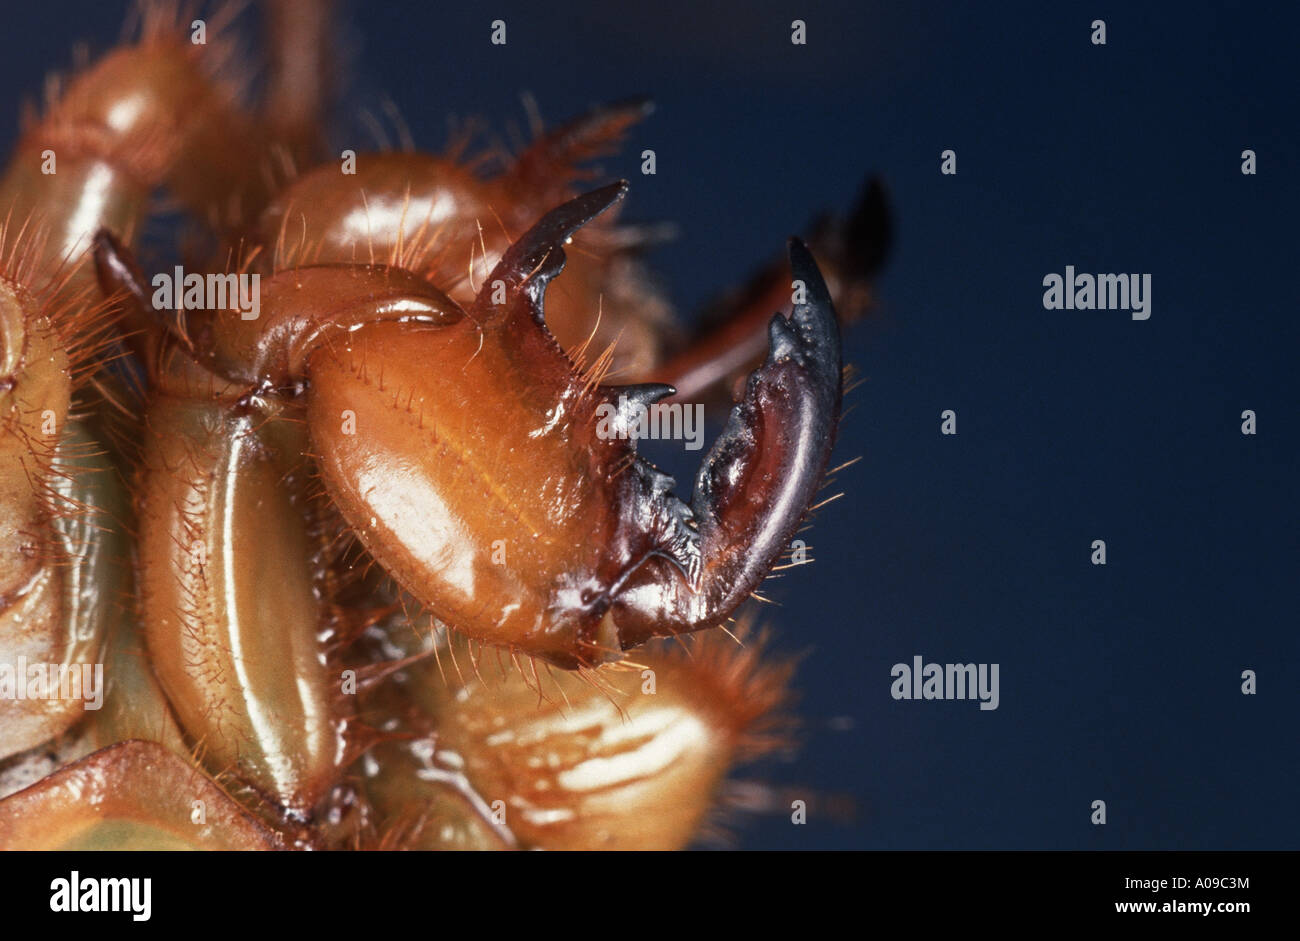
[[111, 183, 841, 668]]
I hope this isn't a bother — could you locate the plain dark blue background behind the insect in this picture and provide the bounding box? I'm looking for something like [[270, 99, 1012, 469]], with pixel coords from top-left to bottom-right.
[[0, 0, 1300, 849]]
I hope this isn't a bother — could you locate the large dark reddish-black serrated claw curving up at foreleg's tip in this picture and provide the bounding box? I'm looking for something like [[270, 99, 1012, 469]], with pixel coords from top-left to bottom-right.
[[612, 239, 842, 649]]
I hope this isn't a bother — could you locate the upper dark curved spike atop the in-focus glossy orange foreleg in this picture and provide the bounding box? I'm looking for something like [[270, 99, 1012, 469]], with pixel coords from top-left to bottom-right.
[[475, 179, 628, 326]]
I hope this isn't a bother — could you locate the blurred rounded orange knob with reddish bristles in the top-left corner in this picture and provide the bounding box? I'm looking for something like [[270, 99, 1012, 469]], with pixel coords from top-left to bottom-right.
[[0, 4, 265, 290]]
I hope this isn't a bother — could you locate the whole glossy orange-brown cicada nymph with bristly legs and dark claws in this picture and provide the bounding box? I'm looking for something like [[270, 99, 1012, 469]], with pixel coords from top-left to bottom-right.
[[0, 3, 885, 849]]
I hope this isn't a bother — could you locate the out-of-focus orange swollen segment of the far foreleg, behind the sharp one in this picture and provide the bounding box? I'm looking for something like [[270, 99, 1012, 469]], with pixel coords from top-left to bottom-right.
[[259, 101, 675, 377]]
